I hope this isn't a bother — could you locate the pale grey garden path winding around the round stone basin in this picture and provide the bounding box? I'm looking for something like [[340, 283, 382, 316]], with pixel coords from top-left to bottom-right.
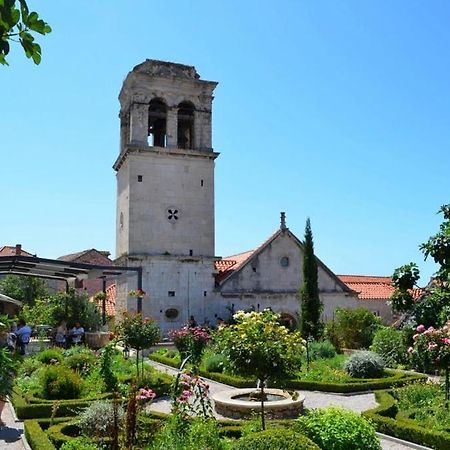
[[146, 360, 425, 450]]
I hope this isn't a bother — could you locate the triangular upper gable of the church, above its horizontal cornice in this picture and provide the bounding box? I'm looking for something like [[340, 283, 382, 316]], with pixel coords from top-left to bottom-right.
[[216, 229, 350, 293]]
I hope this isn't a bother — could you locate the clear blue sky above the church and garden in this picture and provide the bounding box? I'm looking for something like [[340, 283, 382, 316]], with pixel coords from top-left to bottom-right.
[[0, 0, 450, 282]]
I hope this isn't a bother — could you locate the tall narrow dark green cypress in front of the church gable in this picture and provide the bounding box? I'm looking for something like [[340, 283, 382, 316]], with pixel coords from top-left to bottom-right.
[[300, 218, 323, 339]]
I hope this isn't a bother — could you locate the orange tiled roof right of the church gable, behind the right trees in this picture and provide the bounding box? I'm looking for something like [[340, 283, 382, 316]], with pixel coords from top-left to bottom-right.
[[338, 275, 424, 300]]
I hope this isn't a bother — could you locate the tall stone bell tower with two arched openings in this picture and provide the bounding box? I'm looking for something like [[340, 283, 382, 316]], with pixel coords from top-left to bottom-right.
[[113, 60, 218, 331]]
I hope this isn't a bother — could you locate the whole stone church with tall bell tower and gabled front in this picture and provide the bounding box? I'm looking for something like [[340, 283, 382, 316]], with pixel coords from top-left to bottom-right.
[[113, 60, 358, 333]]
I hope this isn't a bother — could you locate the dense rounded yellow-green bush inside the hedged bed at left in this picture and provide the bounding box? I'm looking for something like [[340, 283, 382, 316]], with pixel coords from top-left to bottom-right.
[[41, 366, 82, 400]]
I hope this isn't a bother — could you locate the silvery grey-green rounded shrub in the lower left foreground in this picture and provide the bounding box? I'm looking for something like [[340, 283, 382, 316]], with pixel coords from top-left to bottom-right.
[[78, 400, 124, 437]]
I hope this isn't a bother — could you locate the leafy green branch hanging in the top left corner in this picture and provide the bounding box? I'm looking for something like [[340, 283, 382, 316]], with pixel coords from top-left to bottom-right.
[[0, 0, 52, 65]]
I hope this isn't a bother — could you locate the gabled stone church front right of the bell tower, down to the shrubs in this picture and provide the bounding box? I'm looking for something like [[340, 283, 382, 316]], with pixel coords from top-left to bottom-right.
[[217, 229, 358, 322]]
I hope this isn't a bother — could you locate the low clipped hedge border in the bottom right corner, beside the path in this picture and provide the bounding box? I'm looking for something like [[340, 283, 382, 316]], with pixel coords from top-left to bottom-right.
[[362, 391, 450, 450]]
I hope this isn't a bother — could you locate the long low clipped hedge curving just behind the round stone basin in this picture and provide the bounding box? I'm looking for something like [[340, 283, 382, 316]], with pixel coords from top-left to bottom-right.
[[149, 354, 427, 394]]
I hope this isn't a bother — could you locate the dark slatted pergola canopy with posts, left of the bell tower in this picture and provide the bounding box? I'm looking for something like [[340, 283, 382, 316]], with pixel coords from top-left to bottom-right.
[[0, 255, 142, 323]]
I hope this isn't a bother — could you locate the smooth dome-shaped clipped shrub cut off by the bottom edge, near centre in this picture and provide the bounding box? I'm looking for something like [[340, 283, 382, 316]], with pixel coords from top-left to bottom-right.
[[233, 428, 320, 450]]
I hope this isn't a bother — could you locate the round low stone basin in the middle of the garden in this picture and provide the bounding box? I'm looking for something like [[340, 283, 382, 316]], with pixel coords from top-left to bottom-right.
[[212, 388, 305, 419]]
